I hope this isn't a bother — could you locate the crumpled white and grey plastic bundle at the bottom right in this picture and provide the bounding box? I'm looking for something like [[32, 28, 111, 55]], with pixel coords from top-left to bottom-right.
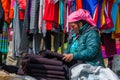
[[71, 64, 120, 80]]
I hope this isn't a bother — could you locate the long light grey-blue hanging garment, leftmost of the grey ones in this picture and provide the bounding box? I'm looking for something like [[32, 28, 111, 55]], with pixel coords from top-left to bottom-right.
[[12, 1, 24, 57]]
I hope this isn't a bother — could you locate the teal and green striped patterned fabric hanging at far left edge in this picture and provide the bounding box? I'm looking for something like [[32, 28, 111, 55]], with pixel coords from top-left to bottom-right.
[[0, 22, 8, 54]]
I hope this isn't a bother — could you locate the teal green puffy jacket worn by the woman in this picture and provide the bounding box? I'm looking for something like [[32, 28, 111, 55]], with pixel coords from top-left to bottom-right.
[[65, 24, 104, 66]]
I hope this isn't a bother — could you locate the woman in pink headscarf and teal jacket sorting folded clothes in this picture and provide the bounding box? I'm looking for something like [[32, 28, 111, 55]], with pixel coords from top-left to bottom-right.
[[63, 9, 104, 66]]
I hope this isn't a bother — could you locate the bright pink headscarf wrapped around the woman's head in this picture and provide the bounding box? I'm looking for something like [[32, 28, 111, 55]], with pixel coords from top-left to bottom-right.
[[68, 9, 96, 26]]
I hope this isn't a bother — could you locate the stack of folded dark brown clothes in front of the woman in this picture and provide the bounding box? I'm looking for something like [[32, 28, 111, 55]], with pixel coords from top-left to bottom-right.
[[18, 50, 66, 80]]
